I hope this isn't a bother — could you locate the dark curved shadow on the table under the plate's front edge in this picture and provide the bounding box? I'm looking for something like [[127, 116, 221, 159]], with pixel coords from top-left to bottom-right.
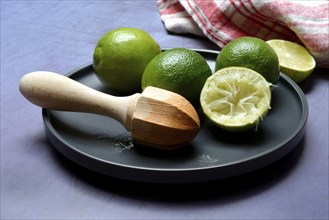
[[47, 138, 304, 203]]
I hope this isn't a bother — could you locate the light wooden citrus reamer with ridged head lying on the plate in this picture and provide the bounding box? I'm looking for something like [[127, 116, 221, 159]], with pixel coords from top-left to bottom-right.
[[19, 71, 200, 149]]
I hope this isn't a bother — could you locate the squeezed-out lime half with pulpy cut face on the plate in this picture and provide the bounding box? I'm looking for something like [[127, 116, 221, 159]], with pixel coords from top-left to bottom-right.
[[200, 67, 272, 132]]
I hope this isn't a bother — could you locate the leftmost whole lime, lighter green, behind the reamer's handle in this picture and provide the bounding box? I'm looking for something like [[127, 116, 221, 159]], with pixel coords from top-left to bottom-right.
[[93, 28, 161, 93]]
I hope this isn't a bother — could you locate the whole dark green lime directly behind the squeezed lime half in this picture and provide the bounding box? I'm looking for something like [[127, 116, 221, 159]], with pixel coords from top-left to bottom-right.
[[215, 37, 280, 84]]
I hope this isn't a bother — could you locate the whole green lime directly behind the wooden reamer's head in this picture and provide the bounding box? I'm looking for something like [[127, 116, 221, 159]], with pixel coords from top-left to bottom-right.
[[142, 48, 212, 105]]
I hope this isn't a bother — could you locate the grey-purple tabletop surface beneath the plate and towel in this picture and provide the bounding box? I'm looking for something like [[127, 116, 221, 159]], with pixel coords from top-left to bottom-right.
[[0, 0, 329, 219]]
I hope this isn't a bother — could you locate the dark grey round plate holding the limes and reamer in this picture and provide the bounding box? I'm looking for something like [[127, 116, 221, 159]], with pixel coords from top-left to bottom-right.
[[43, 50, 308, 183]]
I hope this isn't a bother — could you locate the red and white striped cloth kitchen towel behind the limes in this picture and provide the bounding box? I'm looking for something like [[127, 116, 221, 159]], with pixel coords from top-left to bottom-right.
[[157, 0, 329, 68]]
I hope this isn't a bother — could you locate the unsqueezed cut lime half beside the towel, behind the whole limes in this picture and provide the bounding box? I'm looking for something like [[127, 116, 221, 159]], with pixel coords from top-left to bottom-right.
[[267, 39, 316, 83]]
